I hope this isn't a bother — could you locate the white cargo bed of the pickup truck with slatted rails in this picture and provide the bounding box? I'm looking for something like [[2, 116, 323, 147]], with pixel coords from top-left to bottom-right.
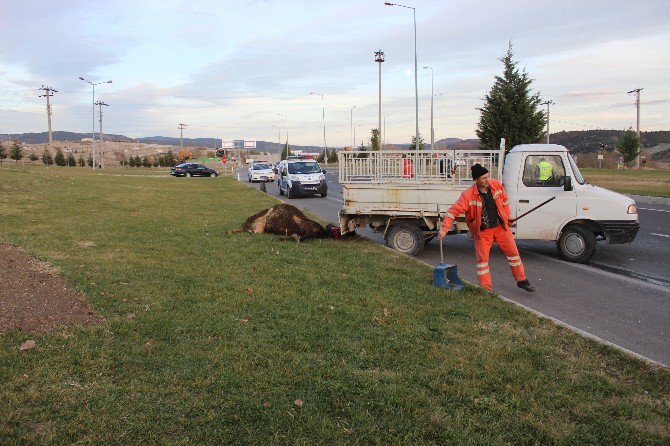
[[338, 150, 504, 237]]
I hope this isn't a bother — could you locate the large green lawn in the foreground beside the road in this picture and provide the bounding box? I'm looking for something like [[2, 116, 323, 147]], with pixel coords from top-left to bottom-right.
[[0, 167, 670, 445]]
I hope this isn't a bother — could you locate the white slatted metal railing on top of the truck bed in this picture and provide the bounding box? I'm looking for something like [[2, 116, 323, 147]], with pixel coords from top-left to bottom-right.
[[338, 150, 504, 186]]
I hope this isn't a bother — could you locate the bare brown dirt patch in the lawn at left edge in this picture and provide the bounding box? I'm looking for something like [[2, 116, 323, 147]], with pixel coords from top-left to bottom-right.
[[0, 243, 102, 333]]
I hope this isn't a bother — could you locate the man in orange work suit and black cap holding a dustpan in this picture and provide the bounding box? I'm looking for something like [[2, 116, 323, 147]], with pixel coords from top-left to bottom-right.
[[437, 164, 535, 292]]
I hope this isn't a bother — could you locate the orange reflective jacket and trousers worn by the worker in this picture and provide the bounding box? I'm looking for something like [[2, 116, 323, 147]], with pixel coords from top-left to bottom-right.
[[442, 179, 526, 290]]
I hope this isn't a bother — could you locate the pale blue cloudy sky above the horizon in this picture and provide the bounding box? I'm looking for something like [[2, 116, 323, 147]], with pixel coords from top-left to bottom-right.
[[0, 0, 670, 146]]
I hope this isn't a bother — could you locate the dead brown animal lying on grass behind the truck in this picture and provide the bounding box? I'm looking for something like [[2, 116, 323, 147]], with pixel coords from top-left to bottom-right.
[[232, 203, 339, 241]]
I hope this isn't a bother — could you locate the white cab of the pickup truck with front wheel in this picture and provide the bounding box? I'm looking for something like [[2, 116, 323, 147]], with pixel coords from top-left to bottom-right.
[[510, 144, 640, 262]]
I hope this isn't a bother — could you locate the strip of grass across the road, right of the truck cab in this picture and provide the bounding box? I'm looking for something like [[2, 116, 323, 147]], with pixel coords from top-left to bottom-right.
[[580, 168, 670, 198]]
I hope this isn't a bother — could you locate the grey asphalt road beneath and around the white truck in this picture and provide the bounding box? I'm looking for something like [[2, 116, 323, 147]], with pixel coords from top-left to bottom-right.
[[240, 170, 670, 366]]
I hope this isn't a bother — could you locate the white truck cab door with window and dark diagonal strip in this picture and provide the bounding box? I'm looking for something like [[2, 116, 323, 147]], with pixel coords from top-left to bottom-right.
[[510, 152, 577, 240]]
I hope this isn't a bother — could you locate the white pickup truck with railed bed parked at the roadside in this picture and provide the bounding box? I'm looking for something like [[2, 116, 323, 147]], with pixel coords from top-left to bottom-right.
[[338, 144, 640, 263]]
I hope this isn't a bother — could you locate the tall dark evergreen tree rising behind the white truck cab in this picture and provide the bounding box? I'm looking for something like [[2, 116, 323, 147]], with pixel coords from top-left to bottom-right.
[[476, 42, 546, 151]]
